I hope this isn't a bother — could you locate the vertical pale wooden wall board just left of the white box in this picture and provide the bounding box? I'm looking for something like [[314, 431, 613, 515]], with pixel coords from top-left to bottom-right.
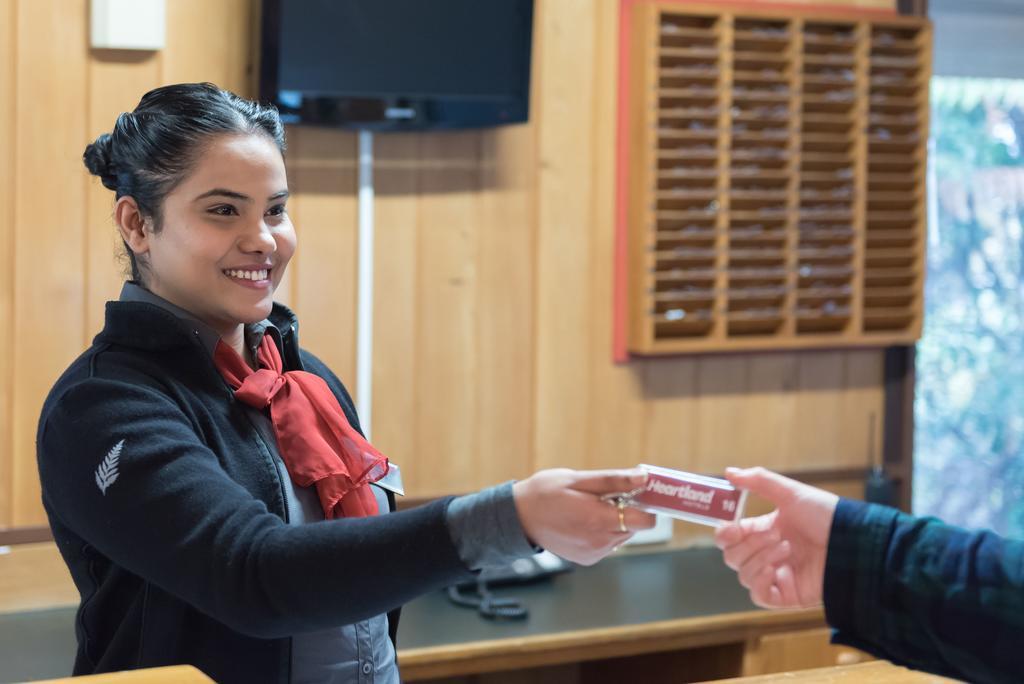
[[11, 0, 88, 525]]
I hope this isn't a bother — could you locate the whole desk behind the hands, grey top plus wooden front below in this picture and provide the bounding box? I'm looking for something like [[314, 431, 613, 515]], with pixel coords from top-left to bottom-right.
[[398, 548, 863, 682]]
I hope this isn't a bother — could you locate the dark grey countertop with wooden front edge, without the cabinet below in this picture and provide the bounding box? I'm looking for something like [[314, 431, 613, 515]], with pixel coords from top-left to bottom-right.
[[398, 548, 824, 680]]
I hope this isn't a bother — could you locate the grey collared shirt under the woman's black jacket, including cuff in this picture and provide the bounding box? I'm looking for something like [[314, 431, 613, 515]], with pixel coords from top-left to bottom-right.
[[121, 282, 539, 684]]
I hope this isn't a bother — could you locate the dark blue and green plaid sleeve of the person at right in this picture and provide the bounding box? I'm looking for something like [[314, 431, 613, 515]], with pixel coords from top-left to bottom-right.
[[823, 499, 1024, 682]]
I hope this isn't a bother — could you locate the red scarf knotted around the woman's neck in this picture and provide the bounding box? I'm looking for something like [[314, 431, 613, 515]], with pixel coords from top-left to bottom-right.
[[213, 335, 388, 520]]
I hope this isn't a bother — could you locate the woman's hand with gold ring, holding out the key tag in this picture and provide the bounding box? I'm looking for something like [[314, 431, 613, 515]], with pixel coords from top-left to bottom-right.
[[512, 468, 654, 565]]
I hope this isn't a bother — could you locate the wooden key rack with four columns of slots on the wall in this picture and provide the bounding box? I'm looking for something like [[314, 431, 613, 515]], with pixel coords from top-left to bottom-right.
[[627, 2, 932, 354]]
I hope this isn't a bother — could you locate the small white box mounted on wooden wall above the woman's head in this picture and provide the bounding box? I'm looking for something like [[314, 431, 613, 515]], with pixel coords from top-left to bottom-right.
[[89, 0, 167, 50]]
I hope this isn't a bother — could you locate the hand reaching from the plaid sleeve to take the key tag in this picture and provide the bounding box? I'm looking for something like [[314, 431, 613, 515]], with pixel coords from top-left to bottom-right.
[[715, 468, 839, 608]]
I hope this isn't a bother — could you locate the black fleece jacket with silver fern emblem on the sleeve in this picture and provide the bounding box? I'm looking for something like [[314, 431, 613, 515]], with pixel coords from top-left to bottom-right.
[[37, 302, 469, 684]]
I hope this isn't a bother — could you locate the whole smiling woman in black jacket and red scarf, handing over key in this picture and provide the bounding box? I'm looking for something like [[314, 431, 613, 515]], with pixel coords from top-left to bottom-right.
[[37, 84, 653, 683]]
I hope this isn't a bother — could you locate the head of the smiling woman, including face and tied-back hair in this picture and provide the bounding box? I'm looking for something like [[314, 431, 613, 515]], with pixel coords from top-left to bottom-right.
[[84, 85, 295, 360]]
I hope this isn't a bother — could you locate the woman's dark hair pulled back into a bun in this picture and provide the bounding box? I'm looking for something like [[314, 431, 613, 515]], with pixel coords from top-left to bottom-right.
[[82, 83, 285, 281]]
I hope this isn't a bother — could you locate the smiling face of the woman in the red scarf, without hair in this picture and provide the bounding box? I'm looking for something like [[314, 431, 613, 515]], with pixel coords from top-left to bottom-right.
[[115, 134, 295, 362]]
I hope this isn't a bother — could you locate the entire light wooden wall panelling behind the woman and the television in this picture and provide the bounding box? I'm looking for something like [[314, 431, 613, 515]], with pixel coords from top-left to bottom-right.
[[0, 0, 892, 527]]
